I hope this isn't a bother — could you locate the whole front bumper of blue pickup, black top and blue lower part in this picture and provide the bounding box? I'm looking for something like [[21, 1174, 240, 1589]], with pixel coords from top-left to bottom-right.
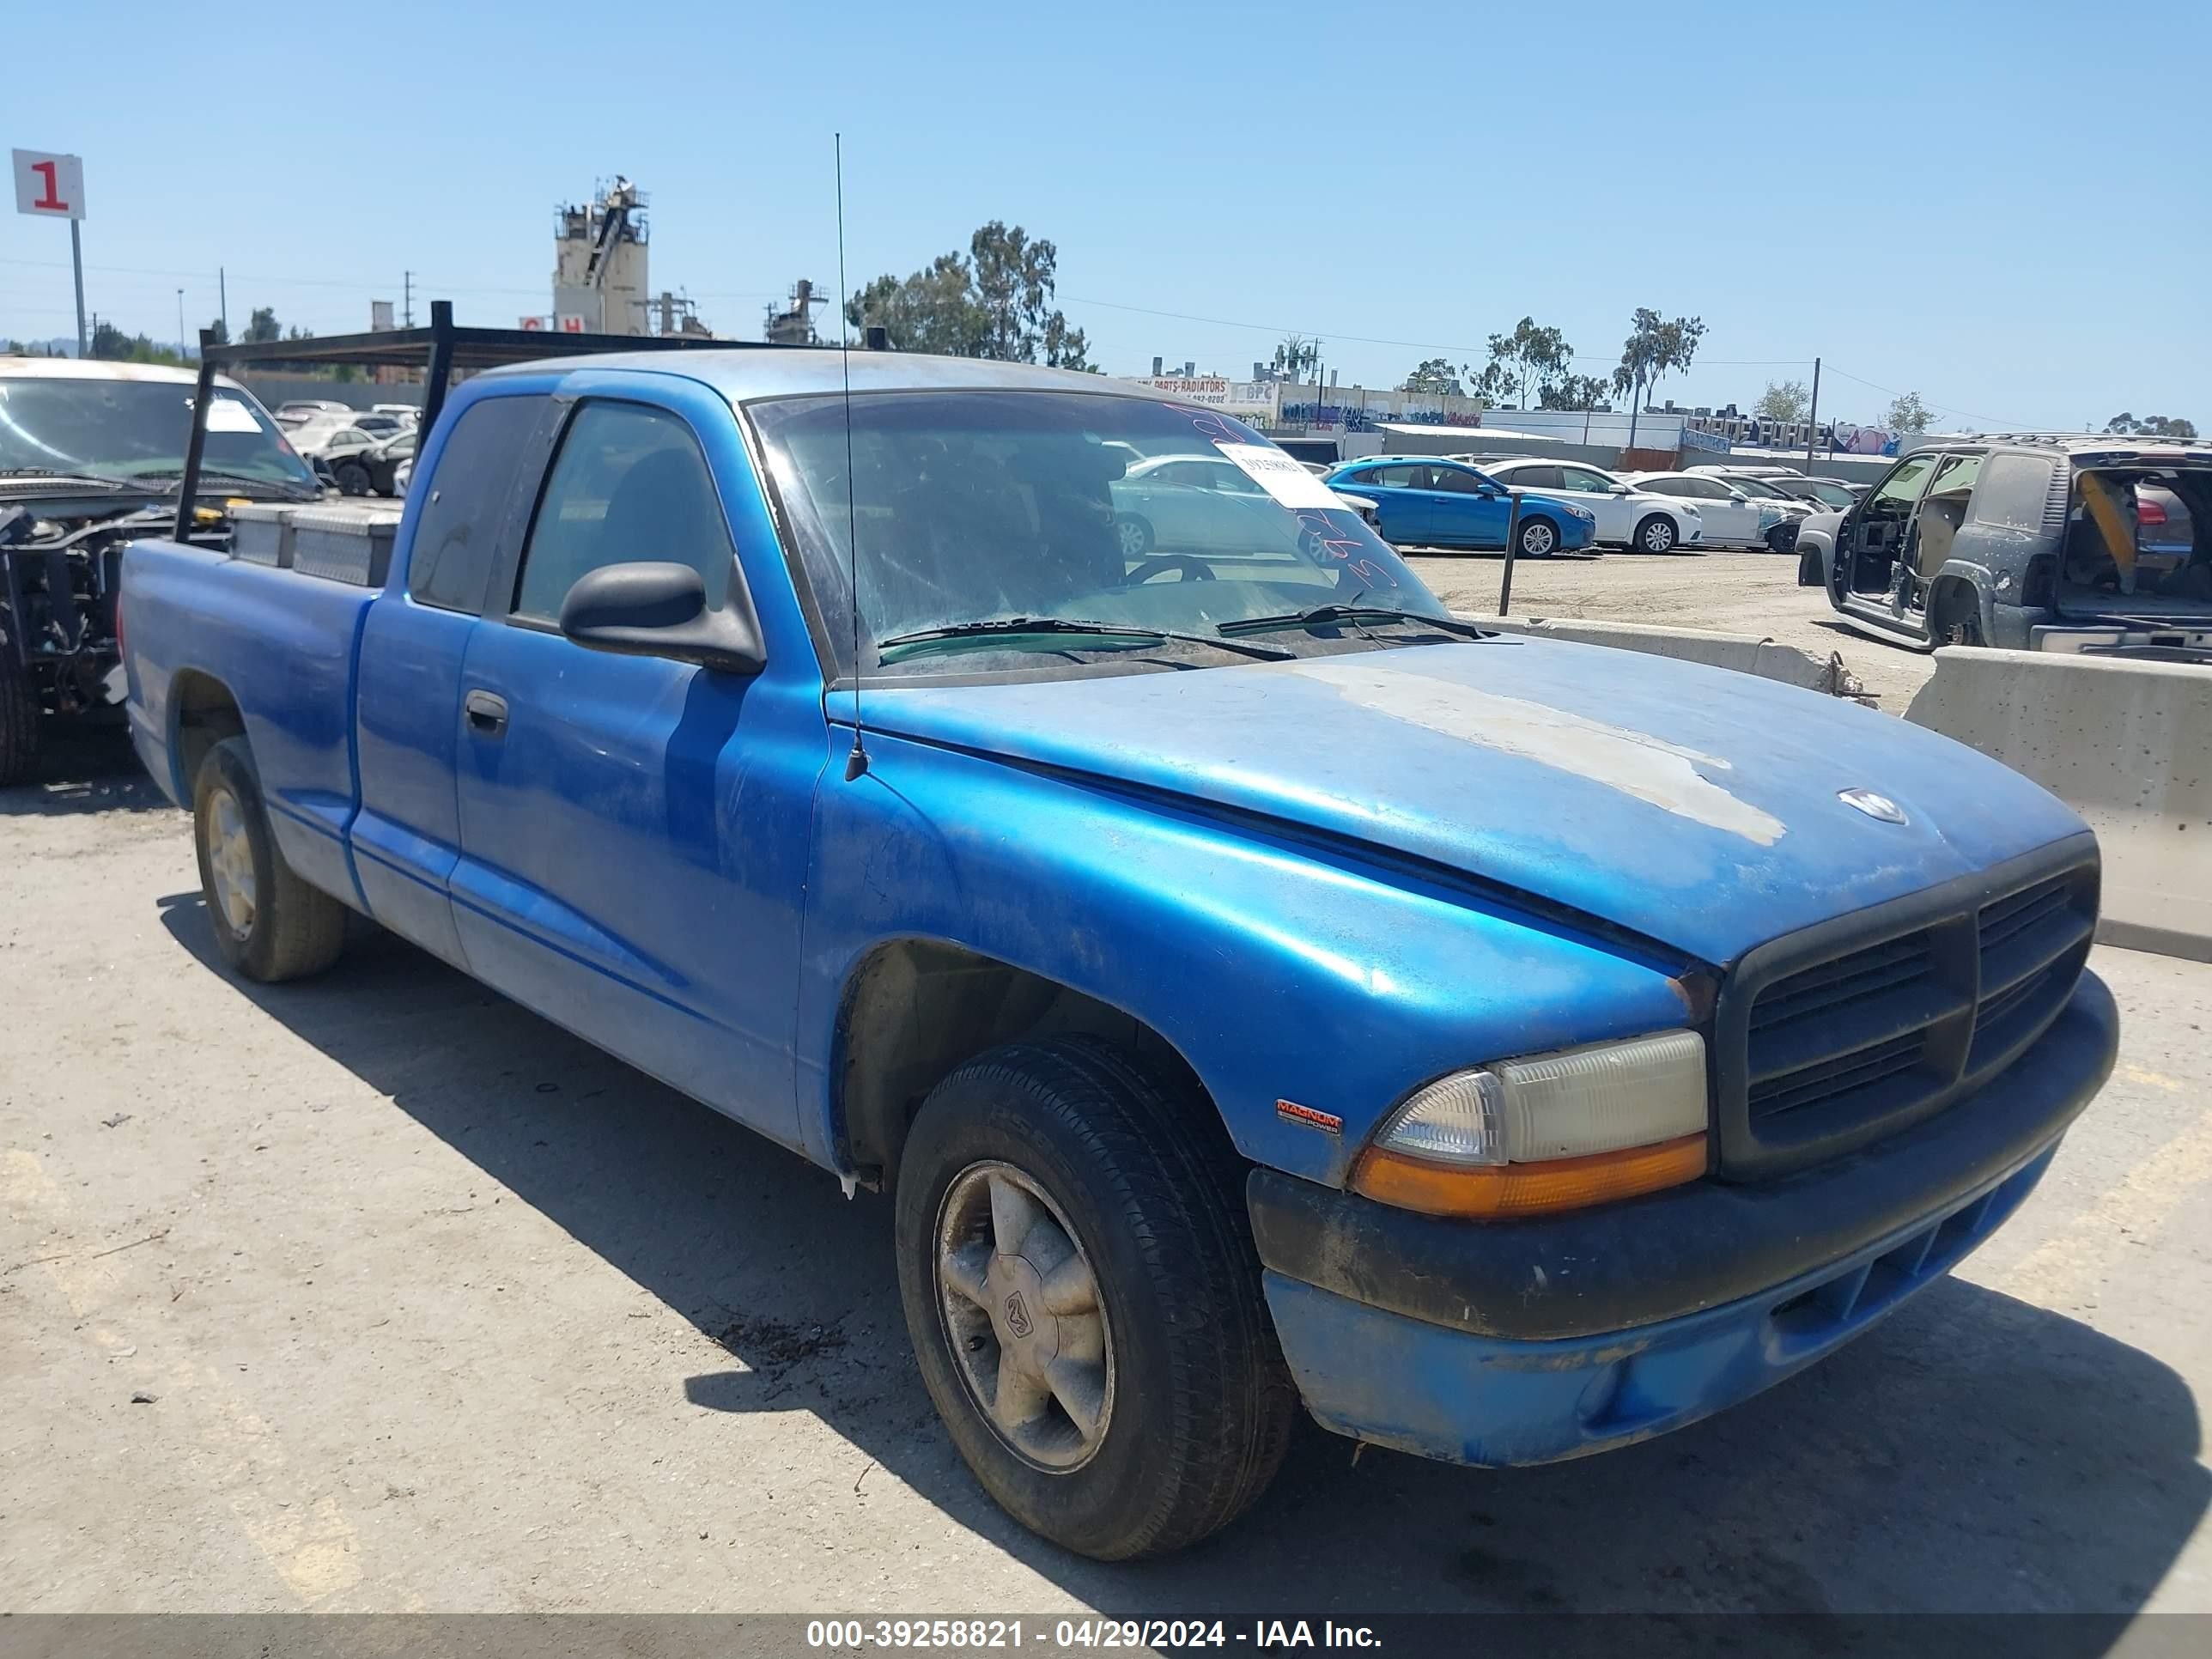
[[1248, 973, 2119, 1467]]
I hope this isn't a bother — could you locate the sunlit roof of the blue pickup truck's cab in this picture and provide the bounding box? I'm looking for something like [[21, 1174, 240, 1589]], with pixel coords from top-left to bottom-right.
[[480, 347, 1164, 403]]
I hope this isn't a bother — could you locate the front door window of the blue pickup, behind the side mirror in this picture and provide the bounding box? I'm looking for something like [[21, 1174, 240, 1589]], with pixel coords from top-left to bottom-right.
[[513, 403, 737, 622]]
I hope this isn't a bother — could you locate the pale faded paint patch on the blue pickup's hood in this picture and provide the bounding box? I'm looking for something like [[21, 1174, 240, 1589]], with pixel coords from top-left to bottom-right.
[[1287, 654, 1783, 848]]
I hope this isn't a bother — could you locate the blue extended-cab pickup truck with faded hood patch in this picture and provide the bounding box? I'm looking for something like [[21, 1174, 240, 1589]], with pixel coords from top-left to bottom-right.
[[122, 349, 2117, 1558]]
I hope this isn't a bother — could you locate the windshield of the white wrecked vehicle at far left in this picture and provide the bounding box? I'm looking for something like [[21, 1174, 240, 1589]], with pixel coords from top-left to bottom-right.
[[0, 378, 314, 489]]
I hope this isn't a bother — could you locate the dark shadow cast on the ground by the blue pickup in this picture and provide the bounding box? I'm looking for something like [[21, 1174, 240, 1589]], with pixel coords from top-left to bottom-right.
[[161, 894, 2212, 1655]]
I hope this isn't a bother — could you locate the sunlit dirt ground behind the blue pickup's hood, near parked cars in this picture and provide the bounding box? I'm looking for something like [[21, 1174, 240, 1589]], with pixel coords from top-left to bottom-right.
[[1411, 553, 1936, 714]]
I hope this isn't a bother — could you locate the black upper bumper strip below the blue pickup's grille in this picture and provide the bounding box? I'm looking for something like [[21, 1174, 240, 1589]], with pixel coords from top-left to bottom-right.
[[1245, 973, 2119, 1340]]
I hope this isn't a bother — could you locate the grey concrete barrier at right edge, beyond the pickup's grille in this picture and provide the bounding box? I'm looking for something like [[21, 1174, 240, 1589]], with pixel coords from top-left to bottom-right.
[[1905, 648, 2212, 963]]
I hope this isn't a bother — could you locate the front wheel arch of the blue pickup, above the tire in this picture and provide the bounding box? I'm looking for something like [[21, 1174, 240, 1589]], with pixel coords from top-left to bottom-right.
[[830, 936, 1234, 1190]]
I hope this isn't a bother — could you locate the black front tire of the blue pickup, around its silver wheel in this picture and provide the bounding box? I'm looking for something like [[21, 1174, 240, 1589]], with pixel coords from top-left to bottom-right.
[[896, 1037, 1298, 1562]]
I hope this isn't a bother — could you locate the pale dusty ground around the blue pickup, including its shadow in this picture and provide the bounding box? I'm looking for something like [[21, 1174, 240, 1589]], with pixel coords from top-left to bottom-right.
[[0, 646, 2212, 1650]]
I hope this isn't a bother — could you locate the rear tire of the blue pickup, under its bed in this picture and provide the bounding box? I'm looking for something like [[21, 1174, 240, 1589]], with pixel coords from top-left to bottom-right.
[[192, 737, 347, 984]]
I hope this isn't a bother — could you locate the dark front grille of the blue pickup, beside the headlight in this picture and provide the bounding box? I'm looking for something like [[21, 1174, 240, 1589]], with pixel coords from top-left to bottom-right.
[[1714, 842, 2097, 1176]]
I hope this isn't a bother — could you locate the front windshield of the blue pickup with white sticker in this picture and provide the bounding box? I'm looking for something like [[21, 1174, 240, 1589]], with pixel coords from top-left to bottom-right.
[[748, 389, 1449, 672]]
